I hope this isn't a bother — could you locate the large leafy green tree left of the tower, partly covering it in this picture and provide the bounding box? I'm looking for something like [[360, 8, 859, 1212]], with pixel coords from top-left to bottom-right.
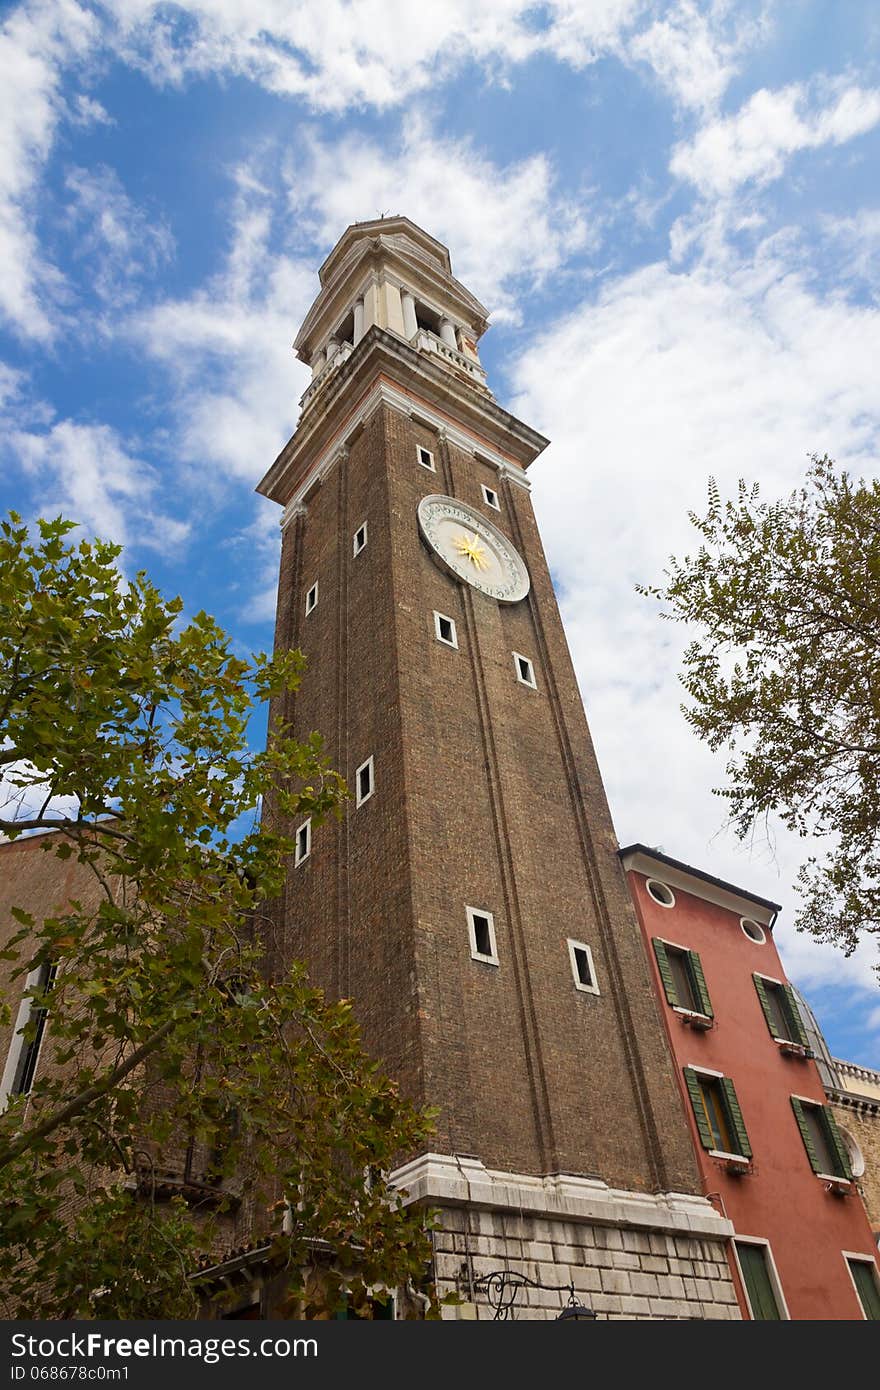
[[0, 514, 430, 1318]]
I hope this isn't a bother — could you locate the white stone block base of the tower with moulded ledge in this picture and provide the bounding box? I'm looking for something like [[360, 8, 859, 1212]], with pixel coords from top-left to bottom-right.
[[393, 1154, 740, 1321]]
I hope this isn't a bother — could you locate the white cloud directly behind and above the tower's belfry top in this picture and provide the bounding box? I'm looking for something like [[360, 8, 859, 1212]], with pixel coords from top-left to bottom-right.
[[288, 118, 596, 322]]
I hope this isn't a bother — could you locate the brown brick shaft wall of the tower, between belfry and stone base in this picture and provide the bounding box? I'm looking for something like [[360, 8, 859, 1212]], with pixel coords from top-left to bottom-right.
[[268, 386, 696, 1190]]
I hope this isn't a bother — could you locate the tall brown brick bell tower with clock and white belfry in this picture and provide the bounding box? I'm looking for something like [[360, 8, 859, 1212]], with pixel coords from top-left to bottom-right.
[[259, 217, 735, 1318]]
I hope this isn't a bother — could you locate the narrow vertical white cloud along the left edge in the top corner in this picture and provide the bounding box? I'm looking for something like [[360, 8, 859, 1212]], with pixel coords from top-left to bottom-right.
[[0, 0, 97, 341]]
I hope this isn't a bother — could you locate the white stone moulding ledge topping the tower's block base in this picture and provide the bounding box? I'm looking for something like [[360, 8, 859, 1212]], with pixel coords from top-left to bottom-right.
[[391, 1154, 734, 1240]]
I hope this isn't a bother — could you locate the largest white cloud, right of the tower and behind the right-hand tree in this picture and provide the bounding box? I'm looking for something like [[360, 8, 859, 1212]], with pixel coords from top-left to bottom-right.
[[512, 233, 880, 1017]]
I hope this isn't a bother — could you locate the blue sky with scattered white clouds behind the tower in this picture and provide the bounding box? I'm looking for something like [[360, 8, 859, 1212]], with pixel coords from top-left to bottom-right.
[[0, 0, 880, 1066]]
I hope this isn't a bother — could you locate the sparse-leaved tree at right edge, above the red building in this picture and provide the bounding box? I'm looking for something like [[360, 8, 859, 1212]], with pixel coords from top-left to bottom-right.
[[639, 456, 880, 954]]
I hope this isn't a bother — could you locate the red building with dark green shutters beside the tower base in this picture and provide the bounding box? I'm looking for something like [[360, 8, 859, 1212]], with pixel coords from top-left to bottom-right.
[[620, 845, 880, 1319]]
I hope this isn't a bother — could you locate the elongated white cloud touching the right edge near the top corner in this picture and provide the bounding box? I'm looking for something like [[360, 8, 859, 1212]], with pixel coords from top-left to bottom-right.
[[670, 82, 880, 196]]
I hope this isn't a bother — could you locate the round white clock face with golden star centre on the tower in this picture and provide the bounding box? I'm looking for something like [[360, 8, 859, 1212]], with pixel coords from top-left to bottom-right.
[[418, 495, 528, 603]]
